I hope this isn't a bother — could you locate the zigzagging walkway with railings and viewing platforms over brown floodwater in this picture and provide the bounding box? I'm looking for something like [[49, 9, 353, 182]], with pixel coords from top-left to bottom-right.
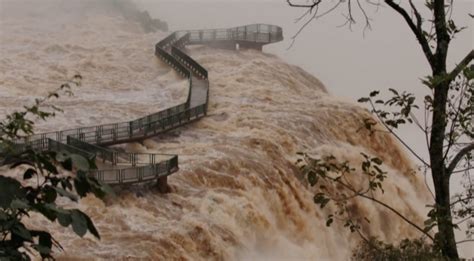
[[19, 24, 283, 186]]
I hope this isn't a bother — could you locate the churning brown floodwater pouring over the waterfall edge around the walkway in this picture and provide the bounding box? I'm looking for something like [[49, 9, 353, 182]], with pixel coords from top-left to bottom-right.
[[0, 1, 428, 260]]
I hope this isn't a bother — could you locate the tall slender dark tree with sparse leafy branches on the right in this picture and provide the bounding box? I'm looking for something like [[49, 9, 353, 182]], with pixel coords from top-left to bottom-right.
[[287, 0, 474, 259]]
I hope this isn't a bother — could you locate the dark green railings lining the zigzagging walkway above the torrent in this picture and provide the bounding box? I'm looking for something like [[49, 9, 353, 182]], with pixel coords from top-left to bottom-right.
[[20, 24, 283, 187]]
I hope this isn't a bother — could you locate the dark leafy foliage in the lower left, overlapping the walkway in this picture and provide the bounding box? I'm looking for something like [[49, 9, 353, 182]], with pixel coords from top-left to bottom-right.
[[0, 75, 111, 260]]
